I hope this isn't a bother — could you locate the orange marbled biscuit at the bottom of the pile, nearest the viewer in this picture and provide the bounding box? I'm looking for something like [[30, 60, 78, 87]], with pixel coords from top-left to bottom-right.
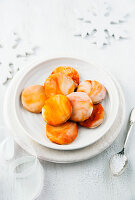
[[46, 122, 78, 144]]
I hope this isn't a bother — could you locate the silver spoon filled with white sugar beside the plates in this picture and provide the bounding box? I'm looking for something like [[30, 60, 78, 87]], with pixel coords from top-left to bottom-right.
[[110, 108, 135, 176]]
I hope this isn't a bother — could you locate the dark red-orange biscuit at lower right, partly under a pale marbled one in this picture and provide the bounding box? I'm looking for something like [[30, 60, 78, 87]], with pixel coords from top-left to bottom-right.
[[79, 104, 104, 128]]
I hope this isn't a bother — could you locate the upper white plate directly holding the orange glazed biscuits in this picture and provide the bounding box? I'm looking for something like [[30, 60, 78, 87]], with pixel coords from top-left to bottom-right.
[[11, 58, 119, 150]]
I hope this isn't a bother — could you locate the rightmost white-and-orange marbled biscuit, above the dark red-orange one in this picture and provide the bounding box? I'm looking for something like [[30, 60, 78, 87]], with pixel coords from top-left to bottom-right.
[[77, 80, 106, 104]]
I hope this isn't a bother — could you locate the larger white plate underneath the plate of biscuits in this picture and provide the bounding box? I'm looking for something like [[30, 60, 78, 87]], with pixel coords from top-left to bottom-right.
[[4, 62, 125, 163]]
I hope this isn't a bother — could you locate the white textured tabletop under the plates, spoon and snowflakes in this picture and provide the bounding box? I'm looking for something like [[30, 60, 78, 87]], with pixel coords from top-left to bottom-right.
[[0, 0, 135, 200]]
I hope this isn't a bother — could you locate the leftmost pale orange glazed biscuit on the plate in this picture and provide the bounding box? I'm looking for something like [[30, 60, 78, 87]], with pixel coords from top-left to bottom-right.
[[21, 85, 46, 113]]
